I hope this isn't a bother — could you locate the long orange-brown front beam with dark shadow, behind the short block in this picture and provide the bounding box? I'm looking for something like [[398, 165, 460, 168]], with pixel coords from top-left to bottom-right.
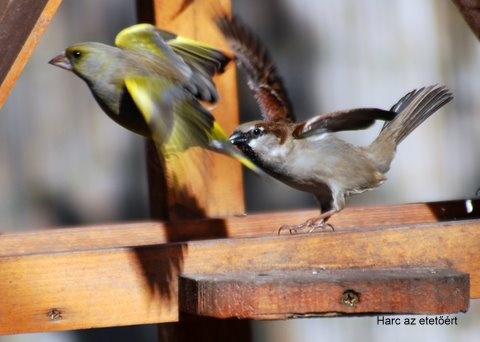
[[0, 220, 480, 334]]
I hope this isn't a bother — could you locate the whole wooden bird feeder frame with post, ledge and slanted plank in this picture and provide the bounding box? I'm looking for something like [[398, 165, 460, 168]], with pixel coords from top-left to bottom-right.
[[0, 0, 480, 341]]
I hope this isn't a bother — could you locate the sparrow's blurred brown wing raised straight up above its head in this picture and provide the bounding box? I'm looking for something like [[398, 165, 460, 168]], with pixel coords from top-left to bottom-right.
[[214, 14, 295, 122]]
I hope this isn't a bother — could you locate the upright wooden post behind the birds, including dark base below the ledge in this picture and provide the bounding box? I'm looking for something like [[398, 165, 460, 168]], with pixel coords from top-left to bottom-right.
[[137, 0, 251, 341]]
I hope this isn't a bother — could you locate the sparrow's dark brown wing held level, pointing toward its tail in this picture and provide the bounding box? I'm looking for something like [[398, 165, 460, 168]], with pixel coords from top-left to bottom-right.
[[293, 108, 397, 139]]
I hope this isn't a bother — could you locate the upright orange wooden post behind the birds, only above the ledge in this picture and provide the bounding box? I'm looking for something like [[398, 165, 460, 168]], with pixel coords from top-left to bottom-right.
[[137, 0, 245, 220]]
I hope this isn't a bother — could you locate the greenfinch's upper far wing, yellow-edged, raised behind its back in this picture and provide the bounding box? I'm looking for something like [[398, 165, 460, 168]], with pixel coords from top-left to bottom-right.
[[115, 24, 230, 103]]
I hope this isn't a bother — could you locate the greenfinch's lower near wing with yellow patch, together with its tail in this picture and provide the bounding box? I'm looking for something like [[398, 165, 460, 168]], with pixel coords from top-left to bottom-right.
[[125, 76, 262, 173]]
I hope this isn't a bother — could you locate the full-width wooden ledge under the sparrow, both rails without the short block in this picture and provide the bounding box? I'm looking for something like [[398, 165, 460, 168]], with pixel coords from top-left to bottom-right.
[[0, 201, 480, 334]]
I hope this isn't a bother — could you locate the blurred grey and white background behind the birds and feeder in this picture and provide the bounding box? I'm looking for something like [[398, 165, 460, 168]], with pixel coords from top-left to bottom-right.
[[0, 0, 480, 342]]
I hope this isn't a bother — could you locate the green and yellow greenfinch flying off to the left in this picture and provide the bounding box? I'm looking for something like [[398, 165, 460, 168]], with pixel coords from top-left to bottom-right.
[[49, 24, 259, 171]]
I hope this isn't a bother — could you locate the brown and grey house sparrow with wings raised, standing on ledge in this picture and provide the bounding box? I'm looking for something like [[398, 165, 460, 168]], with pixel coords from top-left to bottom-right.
[[215, 16, 453, 232]]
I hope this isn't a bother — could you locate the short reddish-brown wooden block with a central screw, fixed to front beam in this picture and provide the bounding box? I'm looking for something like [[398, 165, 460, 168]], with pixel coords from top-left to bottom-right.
[[179, 267, 470, 319]]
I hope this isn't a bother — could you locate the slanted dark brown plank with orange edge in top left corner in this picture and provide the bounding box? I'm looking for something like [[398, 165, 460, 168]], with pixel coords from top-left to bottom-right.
[[0, 0, 61, 108]]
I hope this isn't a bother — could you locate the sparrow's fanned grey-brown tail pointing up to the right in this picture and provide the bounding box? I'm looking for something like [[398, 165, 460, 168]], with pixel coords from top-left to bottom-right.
[[368, 85, 453, 173]]
